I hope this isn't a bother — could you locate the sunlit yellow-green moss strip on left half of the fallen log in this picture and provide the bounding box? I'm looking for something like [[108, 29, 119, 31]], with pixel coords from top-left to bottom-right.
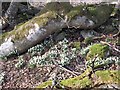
[[0, 11, 56, 41]]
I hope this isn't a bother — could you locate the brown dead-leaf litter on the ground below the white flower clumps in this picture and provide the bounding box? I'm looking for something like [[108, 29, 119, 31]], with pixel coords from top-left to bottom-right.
[[1, 27, 120, 88]]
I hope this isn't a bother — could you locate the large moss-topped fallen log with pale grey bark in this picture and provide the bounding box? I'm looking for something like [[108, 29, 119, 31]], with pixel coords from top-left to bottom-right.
[[0, 2, 114, 57]]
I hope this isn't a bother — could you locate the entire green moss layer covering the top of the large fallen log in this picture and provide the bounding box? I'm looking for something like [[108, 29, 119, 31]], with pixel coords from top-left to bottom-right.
[[0, 2, 113, 45]]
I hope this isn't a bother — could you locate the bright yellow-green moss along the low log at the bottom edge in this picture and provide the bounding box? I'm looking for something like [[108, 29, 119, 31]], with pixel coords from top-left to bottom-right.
[[37, 69, 120, 88]]
